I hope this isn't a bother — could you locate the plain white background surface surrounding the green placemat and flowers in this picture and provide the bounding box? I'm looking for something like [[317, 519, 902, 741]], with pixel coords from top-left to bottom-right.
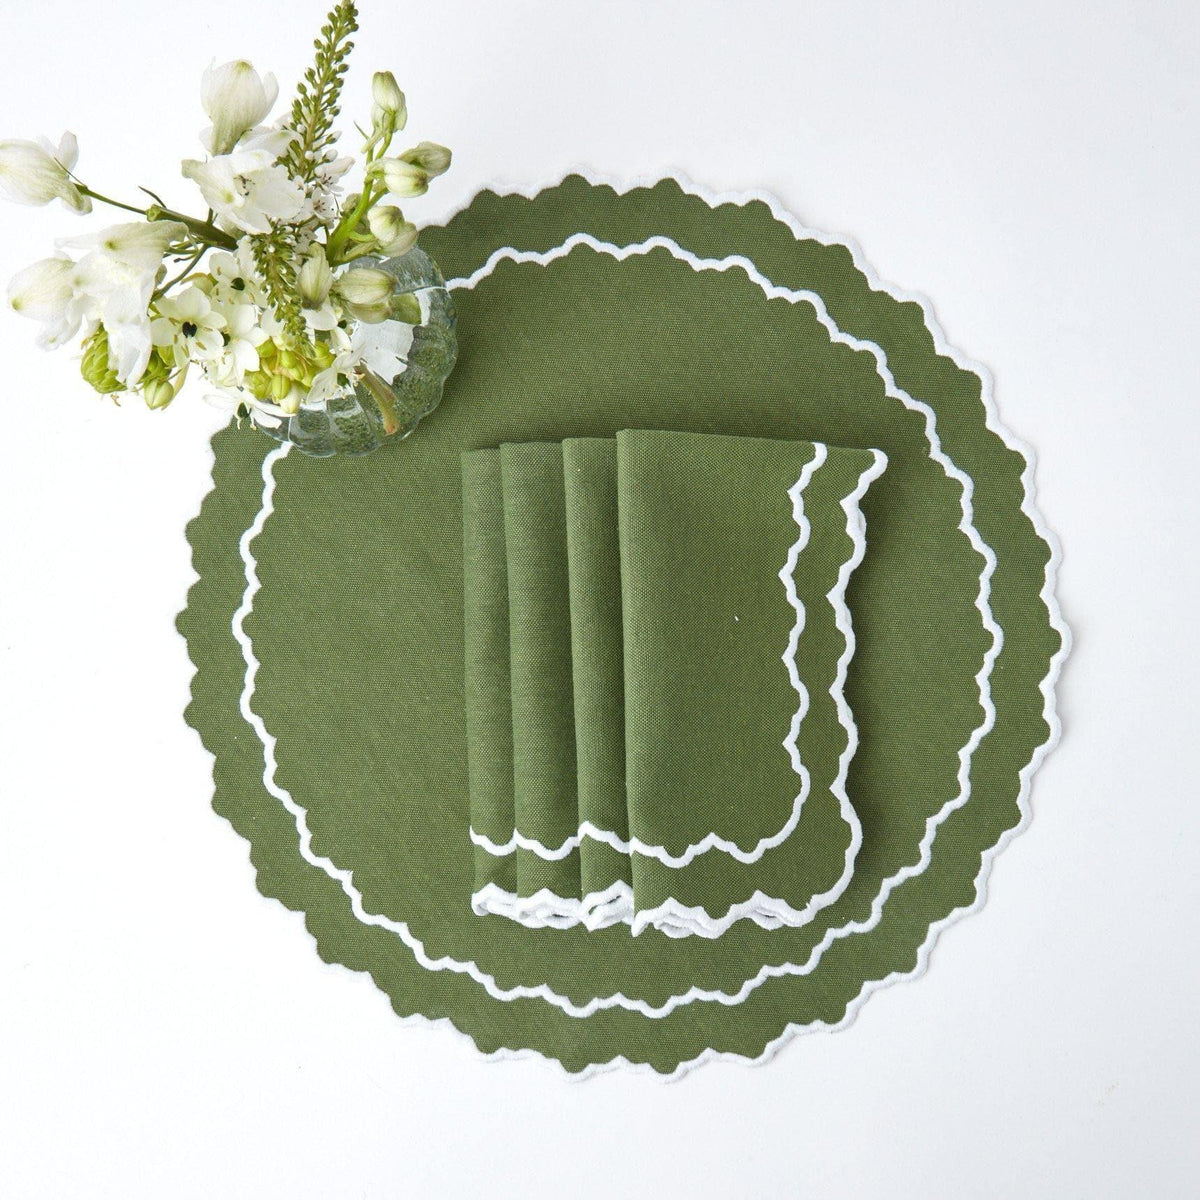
[[0, 0, 1200, 1200]]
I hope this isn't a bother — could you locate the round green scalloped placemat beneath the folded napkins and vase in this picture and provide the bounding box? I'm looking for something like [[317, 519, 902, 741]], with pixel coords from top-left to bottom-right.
[[180, 178, 1063, 1073]]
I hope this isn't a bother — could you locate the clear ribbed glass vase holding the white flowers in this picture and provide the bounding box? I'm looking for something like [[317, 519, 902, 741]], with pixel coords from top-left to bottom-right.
[[251, 247, 458, 458]]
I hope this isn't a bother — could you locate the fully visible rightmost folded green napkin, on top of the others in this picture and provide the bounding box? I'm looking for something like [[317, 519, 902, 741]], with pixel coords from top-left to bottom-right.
[[617, 431, 887, 937]]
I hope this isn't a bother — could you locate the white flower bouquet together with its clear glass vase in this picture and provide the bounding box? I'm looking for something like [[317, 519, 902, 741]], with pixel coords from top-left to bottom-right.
[[0, 0, 456, 455]]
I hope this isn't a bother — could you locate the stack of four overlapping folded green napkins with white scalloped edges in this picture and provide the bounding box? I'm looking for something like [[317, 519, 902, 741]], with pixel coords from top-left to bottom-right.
[[462, 430, 887, 937]]
